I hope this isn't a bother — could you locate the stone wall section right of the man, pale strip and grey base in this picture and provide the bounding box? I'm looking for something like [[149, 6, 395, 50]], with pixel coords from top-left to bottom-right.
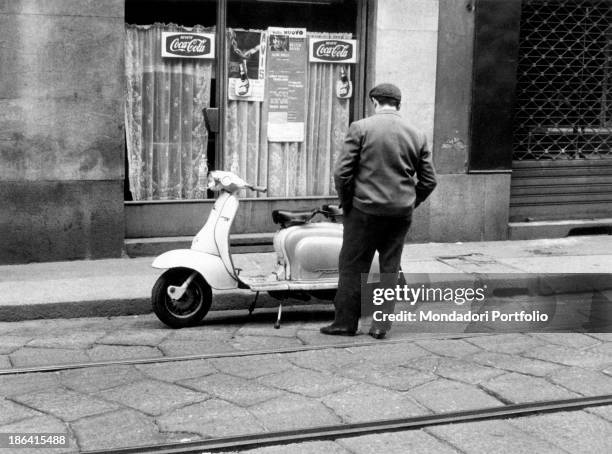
[[368, 0, 510, 242]]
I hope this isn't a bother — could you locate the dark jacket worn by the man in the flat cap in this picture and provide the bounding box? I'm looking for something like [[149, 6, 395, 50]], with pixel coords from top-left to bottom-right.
[[334, 111, 436, 216]]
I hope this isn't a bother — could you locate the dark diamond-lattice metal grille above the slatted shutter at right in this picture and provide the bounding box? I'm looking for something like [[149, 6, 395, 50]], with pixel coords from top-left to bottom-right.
[[513, 0, 612, 160]]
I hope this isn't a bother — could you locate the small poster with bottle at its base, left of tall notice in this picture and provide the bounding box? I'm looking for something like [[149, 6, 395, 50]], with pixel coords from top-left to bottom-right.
[[227, 29, 266, 102]]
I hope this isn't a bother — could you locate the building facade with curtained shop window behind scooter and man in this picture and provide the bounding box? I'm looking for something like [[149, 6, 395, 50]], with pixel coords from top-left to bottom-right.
[[0, 0, 612, 264]]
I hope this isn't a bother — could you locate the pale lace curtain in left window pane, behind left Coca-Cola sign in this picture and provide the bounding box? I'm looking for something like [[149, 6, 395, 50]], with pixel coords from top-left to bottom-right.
[[125, 24, 214, 200]]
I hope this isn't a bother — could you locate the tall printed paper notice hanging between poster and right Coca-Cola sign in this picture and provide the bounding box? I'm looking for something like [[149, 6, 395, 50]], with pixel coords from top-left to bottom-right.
[[267, 27, 308, 142]]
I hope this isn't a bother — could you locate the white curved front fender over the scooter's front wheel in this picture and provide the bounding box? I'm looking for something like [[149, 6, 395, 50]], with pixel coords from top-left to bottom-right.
[[151, 249, 238, 290]]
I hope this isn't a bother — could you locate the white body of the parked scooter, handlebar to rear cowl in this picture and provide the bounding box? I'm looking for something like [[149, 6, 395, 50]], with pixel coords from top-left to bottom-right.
[[152, 171, 364, 326]]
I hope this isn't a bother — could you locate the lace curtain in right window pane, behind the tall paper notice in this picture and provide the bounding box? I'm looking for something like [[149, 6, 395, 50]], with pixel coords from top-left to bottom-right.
[[223, 33, 352, 197]]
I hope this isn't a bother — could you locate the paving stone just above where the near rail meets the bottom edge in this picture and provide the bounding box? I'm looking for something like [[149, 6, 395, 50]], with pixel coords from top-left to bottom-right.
[[72, 410, 165, 450]]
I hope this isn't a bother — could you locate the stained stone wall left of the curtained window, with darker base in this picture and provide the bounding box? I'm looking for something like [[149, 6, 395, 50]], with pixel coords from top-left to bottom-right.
[[0, 0, 124, 263]]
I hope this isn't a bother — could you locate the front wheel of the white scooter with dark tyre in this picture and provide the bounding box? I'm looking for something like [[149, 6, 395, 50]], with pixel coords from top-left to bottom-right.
[[151, 268, 212, 328]]
